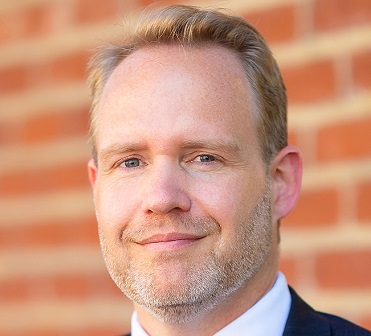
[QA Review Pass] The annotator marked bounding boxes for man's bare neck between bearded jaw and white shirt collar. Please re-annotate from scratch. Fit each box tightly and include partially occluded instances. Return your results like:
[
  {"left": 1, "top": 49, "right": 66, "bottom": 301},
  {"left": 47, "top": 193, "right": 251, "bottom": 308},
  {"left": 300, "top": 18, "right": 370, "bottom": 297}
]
[{"left": 134, "top": 258, "right": 278, "bottom": 336}]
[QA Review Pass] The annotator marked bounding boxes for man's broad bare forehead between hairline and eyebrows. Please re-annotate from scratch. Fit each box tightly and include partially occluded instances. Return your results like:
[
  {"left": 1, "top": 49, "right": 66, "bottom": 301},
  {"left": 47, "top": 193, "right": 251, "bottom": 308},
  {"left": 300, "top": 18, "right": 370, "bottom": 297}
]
[{"left": 96, "top": 45, "right": 260, "bottom": 154}]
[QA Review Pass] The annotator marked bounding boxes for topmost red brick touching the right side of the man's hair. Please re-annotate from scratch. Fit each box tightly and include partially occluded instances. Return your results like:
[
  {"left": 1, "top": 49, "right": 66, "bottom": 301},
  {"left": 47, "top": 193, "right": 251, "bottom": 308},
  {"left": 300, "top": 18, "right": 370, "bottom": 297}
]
[{"left": 243, "top": 5, "right": 296, "bottom": 43}]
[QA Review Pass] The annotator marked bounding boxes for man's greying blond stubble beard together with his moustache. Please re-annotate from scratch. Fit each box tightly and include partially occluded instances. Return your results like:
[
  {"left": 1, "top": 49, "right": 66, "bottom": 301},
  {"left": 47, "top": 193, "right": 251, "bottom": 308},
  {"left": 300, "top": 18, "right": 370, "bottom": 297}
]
[{"left": 100, "top": 183, "right": 272, "bottom": 324}]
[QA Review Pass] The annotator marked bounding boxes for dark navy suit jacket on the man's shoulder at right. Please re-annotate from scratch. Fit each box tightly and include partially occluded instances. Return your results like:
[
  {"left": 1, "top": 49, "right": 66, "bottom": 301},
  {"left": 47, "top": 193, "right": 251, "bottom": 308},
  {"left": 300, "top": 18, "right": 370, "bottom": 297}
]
[{"left": 126, "top": 287, "right": 371, "bottom": 336}]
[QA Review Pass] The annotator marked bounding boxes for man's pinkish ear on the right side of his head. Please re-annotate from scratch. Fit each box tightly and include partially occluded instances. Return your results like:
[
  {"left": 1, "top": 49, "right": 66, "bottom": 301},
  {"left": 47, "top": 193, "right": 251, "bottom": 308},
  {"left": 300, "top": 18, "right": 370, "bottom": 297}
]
[{"left": 270, "top": 146, "right": 303, "bottom": 222}]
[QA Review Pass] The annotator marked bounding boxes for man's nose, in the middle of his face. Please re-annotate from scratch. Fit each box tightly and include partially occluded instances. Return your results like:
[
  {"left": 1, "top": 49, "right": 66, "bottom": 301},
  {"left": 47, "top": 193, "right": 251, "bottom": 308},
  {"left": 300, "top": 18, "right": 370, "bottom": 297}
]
[{"left": 142, "top": 158, "right": 191, "bottom": 214}]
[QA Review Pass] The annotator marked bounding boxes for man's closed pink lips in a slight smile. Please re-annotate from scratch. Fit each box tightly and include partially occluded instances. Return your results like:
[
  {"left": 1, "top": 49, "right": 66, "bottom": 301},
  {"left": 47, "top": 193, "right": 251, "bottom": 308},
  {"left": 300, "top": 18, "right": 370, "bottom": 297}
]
[{"left": 138, "top": 232, "right": 204, "bottom": 251}]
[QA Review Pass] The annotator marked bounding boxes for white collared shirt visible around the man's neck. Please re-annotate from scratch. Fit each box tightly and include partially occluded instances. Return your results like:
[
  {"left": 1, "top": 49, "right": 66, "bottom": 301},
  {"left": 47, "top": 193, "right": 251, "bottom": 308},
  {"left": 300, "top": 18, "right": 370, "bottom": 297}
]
[{"left": 131, "top": 272, "right": 291, "bottom": 336}]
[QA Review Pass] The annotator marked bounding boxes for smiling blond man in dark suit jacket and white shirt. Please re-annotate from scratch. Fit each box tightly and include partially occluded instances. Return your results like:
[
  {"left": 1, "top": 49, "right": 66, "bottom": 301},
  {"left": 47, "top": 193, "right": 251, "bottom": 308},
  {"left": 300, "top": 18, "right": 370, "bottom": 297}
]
[{"left": 89, "top": 6, "right": 370, "bottom": 336}]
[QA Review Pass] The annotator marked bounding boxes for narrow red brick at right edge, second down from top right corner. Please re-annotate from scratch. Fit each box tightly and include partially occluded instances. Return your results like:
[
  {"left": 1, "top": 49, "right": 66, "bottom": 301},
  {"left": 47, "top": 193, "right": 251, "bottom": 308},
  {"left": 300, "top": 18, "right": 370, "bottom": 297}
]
[{"left": 353, "top": 49, "right": 371, "bottom": 89}]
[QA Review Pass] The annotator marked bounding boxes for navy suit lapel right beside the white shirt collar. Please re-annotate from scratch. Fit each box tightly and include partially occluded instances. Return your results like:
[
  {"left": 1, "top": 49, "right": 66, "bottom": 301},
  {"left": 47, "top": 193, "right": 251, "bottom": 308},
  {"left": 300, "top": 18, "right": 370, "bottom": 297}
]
[{"left": 283, "top": 287, "right": 331, "bottom": 336}]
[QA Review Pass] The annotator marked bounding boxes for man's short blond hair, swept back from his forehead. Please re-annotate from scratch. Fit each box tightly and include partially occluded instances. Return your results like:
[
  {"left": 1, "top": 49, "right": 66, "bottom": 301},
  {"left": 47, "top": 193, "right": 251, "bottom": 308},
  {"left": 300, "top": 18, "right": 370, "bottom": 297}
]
[{"left": 89, "top": 5, "right": 287, "bottom": 164}]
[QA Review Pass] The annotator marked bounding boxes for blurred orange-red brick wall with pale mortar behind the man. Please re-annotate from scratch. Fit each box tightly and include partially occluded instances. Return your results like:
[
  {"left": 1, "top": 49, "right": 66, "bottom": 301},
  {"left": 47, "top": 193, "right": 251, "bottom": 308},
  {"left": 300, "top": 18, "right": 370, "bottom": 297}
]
[{"left": 0, "top": 0, "right": 371, "bottom": 335}]
